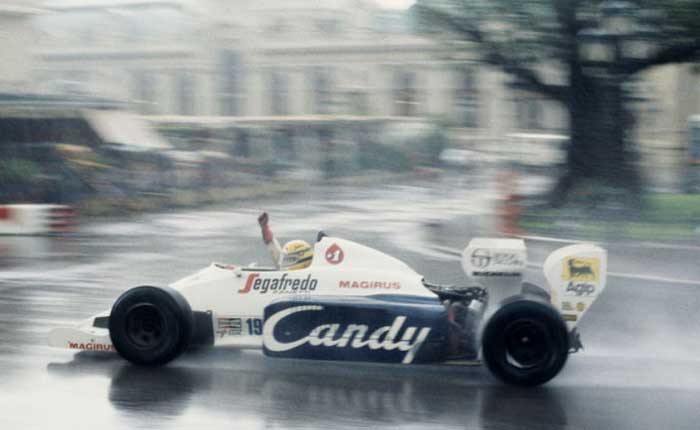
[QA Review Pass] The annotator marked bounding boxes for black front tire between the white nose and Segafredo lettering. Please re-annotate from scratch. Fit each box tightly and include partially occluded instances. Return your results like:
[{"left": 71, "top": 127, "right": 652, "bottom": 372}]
[{"left": 109, "top": 286, "right": 194, "bottom": 366}]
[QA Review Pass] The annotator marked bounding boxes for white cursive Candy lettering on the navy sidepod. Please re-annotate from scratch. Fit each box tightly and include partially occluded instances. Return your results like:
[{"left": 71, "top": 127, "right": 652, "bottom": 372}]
[{"left": 263, "top": 305, "right": 431, "bottom": 363}]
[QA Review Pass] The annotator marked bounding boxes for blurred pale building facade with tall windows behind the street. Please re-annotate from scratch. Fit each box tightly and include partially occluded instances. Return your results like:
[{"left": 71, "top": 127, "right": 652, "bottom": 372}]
[{"left": 32, "top": 0, "right": 700, "bottom": 155}]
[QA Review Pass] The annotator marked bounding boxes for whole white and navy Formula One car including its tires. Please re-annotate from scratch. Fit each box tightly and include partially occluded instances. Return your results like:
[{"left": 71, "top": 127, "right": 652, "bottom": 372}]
[{"left": 49, "top": 233, "right": 607, "bottom": 386}]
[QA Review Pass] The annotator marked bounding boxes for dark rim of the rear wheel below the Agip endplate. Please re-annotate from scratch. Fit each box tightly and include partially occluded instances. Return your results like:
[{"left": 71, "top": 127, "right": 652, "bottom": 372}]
[{"left": 505, "top": 320, "right": 552, "bottom": 369}]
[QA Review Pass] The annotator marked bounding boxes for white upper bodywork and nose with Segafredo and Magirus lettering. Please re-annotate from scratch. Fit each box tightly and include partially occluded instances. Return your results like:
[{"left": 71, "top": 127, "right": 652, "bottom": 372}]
[{"left": 49, "top": 237, "right": 437, "bottom": 351}]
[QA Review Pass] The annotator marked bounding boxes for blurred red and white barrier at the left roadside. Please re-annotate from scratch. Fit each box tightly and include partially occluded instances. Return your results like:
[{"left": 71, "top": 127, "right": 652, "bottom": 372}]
[{"left": 0, "top": 204, "right": 77, "bottom": 235}]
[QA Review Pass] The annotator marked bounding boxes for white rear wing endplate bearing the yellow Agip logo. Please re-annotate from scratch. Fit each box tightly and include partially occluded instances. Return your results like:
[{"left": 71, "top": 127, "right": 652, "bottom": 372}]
[{"left": 544, "top": 244, "right": 608, "bottom": 330}]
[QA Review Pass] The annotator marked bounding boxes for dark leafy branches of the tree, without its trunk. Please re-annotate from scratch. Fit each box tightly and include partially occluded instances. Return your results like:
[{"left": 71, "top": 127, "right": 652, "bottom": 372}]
[{"left": 413, "top": 0, "right": 700, "bottom": 88}]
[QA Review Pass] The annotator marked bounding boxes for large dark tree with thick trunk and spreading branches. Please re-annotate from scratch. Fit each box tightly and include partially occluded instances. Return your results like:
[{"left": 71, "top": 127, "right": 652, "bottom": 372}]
[{"left": 412, "top": 0, "right": 700, "bottom": 204}]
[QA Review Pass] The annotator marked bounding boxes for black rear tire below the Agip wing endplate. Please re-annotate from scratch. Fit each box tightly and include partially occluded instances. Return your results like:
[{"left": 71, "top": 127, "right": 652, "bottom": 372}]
[{"left": 481, "top": 296, "right": 569, "bottom": 386}]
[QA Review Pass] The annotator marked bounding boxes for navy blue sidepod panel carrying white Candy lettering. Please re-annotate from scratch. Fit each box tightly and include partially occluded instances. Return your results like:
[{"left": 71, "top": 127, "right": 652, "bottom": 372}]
[{"left": 263, "top": 295, "right": 448, "bottom": 363}]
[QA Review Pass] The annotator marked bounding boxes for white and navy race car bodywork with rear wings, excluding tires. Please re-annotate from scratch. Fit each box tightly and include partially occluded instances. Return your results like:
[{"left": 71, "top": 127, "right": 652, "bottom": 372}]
[{"left": 49, "top": 235, "right": 606, "bottom": 384}]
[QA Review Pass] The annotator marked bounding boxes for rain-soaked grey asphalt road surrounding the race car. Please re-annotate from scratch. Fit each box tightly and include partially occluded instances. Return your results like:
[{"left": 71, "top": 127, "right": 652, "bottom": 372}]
[{"left": 0, "top": 176, "right": 700, "bottom": 429}]
